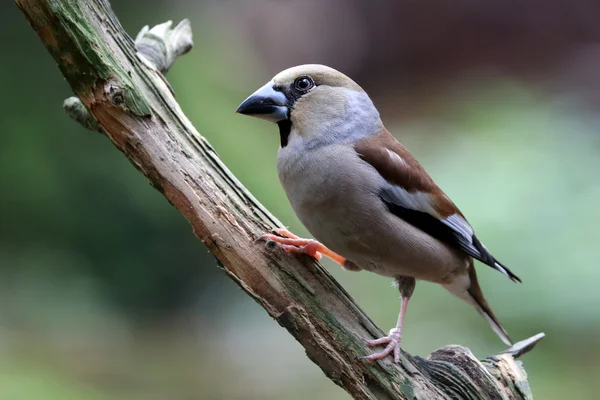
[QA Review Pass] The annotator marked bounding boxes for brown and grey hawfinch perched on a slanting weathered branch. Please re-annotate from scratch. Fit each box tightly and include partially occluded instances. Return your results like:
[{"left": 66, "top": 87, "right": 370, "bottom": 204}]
[{"left": 236, "top": 64, "right": 521, "bottom": 363}]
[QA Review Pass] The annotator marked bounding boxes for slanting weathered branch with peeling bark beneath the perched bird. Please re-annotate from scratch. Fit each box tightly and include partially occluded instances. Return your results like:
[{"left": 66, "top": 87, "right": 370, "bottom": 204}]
[{"left": 16, "top": 0, "right": 543, "bottom": 399}]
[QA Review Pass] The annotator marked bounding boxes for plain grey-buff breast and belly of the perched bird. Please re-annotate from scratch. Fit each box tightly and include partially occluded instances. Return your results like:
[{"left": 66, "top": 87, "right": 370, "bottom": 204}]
[{"left": 278, "top": 146, "right": 469, "bottom": 283}]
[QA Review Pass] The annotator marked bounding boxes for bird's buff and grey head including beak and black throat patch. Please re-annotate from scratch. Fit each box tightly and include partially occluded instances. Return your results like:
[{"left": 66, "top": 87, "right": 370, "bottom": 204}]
[{"left": 237, "top": 64, "right": 381, "bottom": 147}]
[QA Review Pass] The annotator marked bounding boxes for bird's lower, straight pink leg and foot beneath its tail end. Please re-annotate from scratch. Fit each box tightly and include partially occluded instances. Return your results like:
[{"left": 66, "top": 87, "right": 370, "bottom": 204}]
[{"left": 361, "top": 276, "right": 416, "bottom": 363}]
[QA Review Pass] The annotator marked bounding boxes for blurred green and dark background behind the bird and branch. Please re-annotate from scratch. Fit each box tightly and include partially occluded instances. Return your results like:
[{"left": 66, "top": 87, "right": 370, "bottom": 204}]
[{"left": 0, "top": 0, "right": 600, "bottom": 400}]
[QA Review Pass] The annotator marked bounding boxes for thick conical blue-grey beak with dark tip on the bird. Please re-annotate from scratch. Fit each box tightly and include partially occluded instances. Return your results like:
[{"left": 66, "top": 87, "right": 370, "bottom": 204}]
[{"left": 236, "top": 82, "right": 289, "bottom": 122}]
